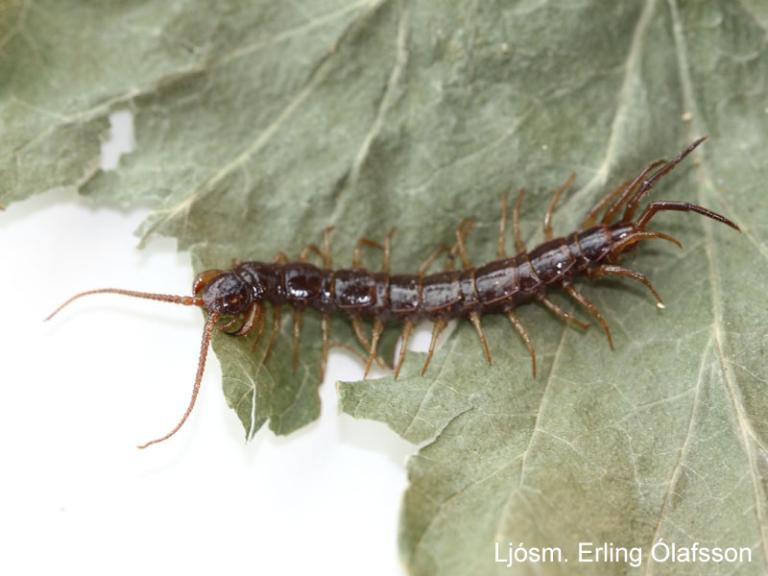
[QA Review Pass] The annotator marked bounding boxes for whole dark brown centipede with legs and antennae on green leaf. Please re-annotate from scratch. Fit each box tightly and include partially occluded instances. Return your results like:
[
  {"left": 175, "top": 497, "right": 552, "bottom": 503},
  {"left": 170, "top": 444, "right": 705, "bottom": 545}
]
[{"left": 46, "top": 137, "right": 740, "bottom": 449}]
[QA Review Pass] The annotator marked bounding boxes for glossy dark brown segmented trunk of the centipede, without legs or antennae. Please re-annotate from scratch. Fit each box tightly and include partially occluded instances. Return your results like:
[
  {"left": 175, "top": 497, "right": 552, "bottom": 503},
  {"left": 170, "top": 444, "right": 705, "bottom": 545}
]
[{"left": 214, "top": 223, "right": 633, "bottom": 320}]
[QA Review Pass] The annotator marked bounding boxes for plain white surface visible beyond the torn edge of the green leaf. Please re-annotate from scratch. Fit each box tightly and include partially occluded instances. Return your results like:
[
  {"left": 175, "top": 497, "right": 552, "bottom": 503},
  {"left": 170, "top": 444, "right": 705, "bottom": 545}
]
[{"left": 0, "top": 112, "right": 414, "bottom": 576}]
